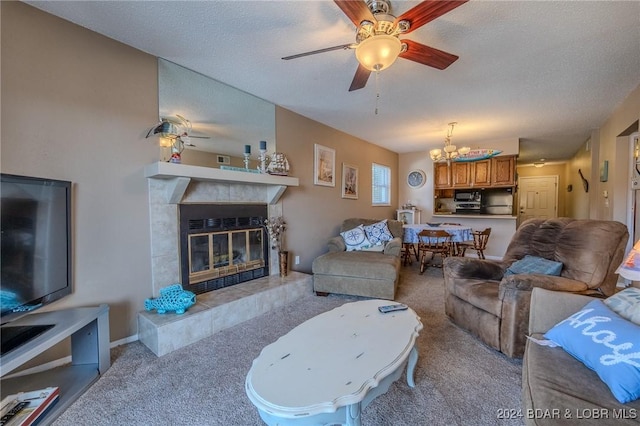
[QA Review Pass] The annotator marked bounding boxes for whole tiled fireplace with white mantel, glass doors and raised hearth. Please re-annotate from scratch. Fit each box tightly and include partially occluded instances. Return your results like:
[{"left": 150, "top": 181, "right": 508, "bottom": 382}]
[{"left": 138, "top": 162, "right": 312, "bottom": 356}]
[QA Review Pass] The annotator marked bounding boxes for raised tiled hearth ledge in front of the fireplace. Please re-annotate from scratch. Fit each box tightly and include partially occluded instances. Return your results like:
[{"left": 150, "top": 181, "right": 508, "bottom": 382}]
[{"left": 138, "top": 272, "right": 312, "bottom": 356}]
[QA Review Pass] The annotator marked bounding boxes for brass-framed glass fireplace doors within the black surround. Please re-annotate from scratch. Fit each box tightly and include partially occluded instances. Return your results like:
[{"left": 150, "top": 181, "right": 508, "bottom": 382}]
[{"left": 188, "top": 228, "right": 265, "bottom": 284}]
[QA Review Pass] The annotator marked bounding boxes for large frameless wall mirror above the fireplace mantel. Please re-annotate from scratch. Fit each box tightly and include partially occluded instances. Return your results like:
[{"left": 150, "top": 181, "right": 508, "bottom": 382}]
[{"left": 158, "top": 58, "right": 276, "bottom": 167}]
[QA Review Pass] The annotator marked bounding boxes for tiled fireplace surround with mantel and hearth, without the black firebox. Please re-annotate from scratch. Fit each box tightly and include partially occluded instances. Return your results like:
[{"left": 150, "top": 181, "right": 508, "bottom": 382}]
[{"left": 138, "top": 162, "right": 312, "bottom": 356}]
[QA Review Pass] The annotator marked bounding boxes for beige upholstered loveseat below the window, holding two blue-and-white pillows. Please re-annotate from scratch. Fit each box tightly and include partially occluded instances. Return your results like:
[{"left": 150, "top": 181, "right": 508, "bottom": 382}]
[{"left": 311, "top": 218, "right": 403, "bottom": 300}]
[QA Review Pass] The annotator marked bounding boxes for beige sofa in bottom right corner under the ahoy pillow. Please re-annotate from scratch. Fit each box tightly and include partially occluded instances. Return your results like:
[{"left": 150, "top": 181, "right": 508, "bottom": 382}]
[{"left": 522, "top": 288, "right": 640, "bottom": 425}]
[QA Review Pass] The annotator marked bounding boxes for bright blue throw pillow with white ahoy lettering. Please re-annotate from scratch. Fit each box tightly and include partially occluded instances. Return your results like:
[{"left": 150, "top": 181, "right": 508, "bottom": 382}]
[{"left": 544, "top": 299, "right": 640, "bottom": 404}]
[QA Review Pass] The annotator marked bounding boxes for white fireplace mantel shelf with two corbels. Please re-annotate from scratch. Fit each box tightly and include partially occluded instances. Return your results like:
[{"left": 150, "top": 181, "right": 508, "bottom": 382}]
[{"left": 144, "top": 161, "right": 299, "bottom": 204}]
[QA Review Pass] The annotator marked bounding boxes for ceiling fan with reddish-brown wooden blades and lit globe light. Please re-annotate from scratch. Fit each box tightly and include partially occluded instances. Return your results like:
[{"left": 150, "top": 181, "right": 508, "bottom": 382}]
[{"left": 282, "top": 0, "right": 468, "bottom": 92}]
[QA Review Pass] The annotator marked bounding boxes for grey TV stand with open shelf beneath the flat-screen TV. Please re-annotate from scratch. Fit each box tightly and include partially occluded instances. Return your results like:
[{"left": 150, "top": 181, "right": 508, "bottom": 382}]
[{"left": 0, "top": 305, "right": 111, "bottom": 424}]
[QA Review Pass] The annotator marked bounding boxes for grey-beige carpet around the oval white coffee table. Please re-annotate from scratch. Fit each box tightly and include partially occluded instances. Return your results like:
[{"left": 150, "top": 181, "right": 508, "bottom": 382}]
[{"left": 54, "top": 262, "right": 522, "bottom": 426}]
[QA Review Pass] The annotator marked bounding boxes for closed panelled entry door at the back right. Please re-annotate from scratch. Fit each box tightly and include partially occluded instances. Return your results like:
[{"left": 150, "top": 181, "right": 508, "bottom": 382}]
[{"left": 518, "top": 176, "right": 558, "bottom": 225}]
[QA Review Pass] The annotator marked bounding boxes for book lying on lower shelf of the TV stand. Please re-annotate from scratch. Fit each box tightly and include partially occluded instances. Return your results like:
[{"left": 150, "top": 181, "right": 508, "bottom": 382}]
[{"left": 0, "top": 386, "right": 60, "bottom": 426}]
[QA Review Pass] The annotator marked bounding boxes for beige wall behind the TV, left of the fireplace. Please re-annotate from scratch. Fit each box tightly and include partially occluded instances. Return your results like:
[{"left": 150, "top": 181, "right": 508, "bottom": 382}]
[{"left": 0, "top": 2, "right": 158, "bottom": 352}]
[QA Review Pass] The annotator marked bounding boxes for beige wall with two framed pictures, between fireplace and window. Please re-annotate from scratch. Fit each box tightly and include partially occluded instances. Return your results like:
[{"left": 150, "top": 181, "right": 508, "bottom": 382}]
[{"left": 276, "top": 107, "right": 398, "bottom": 272}]
